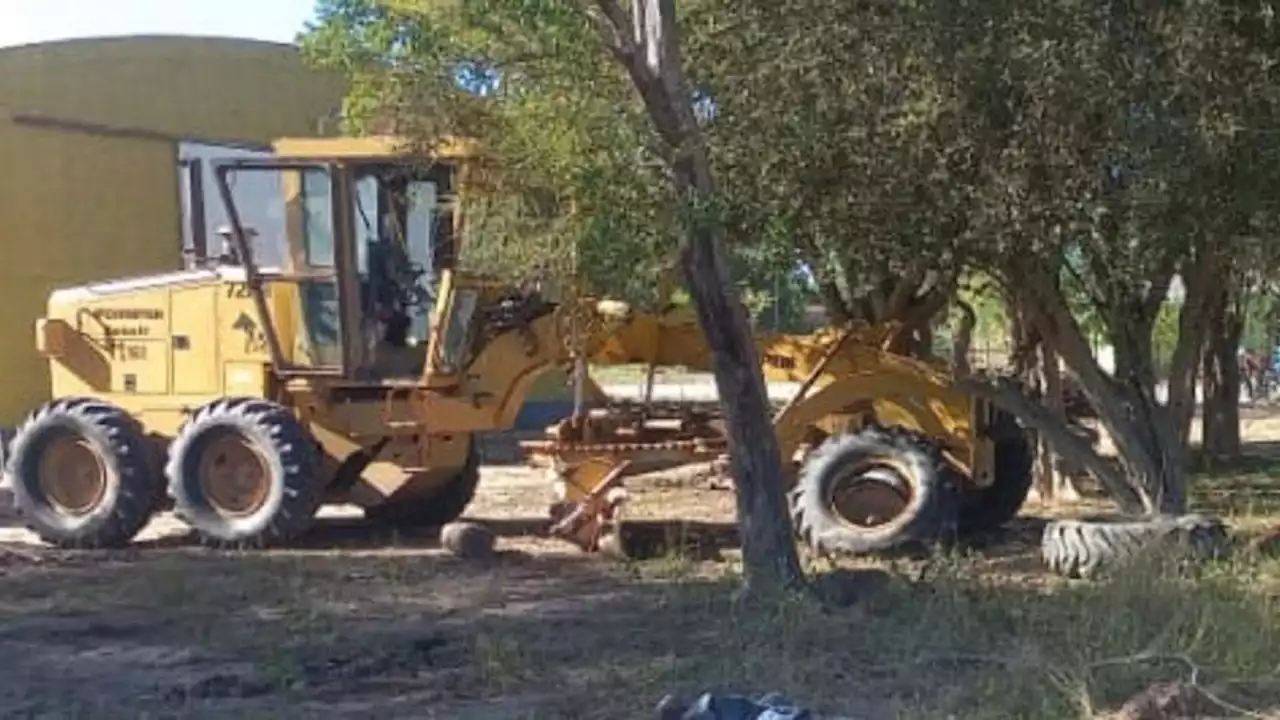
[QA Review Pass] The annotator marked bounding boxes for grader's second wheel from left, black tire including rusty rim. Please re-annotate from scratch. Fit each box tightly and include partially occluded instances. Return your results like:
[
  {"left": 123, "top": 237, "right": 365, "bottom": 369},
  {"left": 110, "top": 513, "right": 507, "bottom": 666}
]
[{"left": 165, "top": 397, "right": 324, "bottom": 548}]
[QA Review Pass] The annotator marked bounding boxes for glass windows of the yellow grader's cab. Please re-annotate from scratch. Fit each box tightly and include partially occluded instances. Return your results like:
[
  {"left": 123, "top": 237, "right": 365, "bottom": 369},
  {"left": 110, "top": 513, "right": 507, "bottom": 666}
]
[{"left": 216, "top": 163, "right": 453, "bottom": 379}]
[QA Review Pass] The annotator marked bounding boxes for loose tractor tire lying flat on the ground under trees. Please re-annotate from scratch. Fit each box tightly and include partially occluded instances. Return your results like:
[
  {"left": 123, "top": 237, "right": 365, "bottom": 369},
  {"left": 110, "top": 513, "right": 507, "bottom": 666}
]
[{"left": 1041, "top": 514, "right": 1230, "bottom": 578}]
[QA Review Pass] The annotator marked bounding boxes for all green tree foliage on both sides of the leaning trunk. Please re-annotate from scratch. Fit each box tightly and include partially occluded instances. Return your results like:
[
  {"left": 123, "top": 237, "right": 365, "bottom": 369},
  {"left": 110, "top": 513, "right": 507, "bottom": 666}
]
[{"left": 305, "top": 0, "right": 1280, "bottom": 507}]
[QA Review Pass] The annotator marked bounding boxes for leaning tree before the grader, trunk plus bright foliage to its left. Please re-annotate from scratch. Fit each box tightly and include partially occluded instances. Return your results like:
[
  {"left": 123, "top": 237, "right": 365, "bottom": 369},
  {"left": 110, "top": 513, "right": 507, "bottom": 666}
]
[{"left": 307, "top": 0, "right": 804, "bottom": 592}]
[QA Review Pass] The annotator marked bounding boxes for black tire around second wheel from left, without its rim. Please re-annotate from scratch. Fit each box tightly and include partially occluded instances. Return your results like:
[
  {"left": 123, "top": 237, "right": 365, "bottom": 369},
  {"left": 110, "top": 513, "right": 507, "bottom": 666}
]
[{"left": 165, "top": 397, "right": 324, "bottom": 548}]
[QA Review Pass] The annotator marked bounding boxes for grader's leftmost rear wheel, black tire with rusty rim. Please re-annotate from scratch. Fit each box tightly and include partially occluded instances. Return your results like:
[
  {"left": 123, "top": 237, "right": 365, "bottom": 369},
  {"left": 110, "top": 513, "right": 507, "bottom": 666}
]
[{"left": 8, "top": 397, "right": 164, "bottom": 548}]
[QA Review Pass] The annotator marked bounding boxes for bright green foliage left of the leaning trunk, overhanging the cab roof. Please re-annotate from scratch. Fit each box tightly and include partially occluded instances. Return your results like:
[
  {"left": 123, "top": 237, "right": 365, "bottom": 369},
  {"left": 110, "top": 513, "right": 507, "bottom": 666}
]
[{"left": 302, "top": 0, "right": 675, "bottom": 305}]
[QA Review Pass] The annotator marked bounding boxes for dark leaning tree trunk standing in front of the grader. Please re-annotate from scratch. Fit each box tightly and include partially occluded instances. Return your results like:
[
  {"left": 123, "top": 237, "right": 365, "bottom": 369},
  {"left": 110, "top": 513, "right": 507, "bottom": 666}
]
[{"left": 596, "top": 0, "right": 804, "bottom": 593}]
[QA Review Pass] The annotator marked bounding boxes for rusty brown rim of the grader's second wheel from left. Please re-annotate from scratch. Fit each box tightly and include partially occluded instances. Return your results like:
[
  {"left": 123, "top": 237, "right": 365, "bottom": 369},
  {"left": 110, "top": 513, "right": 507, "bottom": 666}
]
[{"left": 196, "top": 430, "right": 271, "bottom": 516}]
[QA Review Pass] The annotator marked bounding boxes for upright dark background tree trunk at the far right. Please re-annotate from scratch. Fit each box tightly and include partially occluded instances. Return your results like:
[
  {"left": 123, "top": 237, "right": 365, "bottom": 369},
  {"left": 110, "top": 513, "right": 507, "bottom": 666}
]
[{"left": 1201, "top": 290, "right": 1244, "bottom": 466}]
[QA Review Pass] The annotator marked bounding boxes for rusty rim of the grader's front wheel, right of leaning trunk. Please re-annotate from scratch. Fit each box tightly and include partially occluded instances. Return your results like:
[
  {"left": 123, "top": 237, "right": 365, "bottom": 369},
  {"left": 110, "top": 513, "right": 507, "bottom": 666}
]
[{"left": 828, "top": 457, "right": 911, "bottom": 529}]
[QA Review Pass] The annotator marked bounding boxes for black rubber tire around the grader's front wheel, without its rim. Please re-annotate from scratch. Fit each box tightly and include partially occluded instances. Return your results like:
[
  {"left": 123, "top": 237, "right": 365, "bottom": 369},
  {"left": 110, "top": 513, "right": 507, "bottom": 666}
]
[{"left": 788, "top": 425, "right": 959, "bottom": 555}]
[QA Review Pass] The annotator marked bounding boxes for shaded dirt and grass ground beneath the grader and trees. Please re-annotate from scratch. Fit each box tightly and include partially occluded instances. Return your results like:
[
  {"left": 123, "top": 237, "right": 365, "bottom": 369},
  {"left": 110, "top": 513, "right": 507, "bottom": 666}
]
[{"left": 0, "top": 411, "right": 1280, "bottom": 720}]
